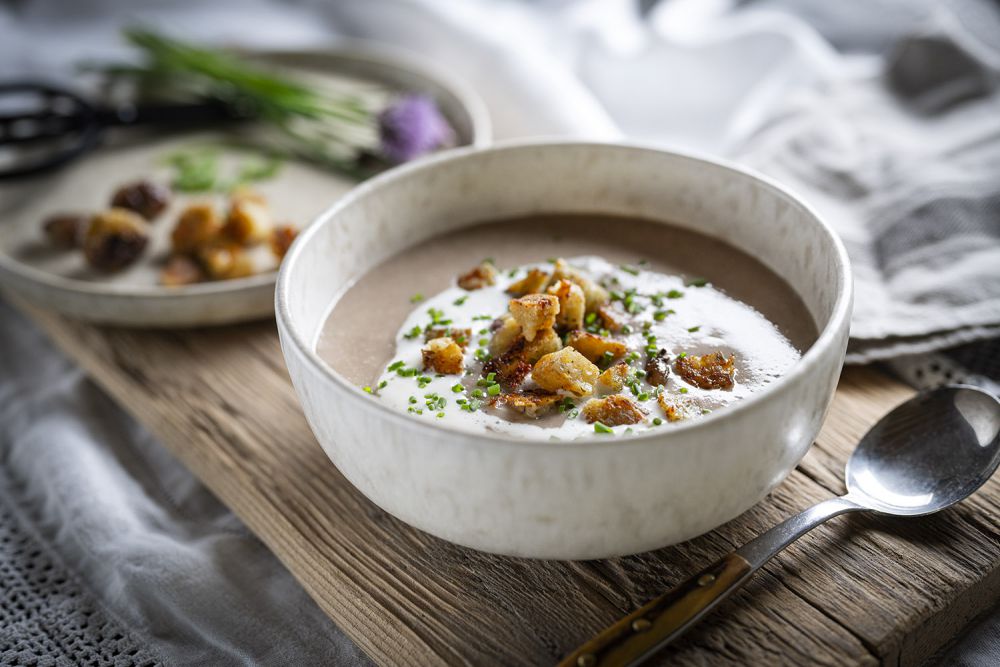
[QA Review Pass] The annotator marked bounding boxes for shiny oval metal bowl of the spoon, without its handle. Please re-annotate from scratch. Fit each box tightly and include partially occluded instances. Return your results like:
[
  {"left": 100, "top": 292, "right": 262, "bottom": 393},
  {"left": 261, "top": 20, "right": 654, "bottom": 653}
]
[{"left": 846, "top": 385, "right": 1000, "bottom": 516}]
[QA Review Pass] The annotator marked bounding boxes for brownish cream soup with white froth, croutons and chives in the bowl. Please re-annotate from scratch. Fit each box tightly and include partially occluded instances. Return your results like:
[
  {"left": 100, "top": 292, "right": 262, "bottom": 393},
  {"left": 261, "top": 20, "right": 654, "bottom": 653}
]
[{"left": 317, "top": 214, "right": 817, "bottom": 440}]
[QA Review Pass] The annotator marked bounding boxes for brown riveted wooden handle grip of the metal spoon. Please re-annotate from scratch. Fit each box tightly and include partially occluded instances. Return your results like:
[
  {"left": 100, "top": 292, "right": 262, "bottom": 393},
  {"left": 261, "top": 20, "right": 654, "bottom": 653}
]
[{"left": 559, "top": 553, "right": 755, "bottom": 667}]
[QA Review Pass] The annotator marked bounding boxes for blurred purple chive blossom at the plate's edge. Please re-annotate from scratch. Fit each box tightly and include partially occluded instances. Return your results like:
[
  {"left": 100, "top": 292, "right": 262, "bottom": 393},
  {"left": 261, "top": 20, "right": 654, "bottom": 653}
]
[{"left": 378, "top": 95, "right": 453, "bottom": 163}]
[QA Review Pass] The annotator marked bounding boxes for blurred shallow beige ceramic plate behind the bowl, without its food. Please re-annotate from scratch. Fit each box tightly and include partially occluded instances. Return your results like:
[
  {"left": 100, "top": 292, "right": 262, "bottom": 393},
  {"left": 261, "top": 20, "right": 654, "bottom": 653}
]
[{"left": 0, "top": 44, "right": 490, "bottom": 327}]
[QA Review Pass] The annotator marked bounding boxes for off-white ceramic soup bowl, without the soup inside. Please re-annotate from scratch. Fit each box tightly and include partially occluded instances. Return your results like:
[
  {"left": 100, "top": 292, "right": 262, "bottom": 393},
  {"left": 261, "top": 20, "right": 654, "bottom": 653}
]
[{"left": 276, "top": 142, "right": 852, "bottom": 559}]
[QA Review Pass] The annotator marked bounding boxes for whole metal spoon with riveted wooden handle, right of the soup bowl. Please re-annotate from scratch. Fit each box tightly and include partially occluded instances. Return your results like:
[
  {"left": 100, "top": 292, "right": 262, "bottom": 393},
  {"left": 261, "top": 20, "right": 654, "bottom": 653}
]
[{"left": 560, "top": 385, "right": 1000, "bottom": 667}]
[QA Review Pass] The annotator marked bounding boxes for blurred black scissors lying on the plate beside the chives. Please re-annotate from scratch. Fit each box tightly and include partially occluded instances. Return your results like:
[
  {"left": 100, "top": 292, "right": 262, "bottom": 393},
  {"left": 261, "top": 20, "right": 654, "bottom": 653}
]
[{"left": 0, "top": 81, "right": 253, "bottom": 181}]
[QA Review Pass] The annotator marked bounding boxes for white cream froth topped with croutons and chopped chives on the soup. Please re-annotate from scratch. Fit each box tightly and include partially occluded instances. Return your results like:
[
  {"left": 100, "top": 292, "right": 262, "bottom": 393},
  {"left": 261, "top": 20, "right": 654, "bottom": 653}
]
[{"left": 365, "top": 256, "right": 800, "bottom": 440}]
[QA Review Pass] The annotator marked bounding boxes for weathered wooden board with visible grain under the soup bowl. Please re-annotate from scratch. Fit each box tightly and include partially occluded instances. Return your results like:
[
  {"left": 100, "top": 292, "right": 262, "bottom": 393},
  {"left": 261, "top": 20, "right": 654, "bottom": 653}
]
[{"left": 9, "top": 308, "right": 1000, "bottom": 667}]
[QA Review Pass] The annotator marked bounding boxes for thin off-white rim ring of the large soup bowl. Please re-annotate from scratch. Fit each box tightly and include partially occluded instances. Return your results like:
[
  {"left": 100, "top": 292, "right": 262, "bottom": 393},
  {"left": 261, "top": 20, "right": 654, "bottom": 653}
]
[{"left": 274, "top": 138, "right": 854, "bottom": 450}]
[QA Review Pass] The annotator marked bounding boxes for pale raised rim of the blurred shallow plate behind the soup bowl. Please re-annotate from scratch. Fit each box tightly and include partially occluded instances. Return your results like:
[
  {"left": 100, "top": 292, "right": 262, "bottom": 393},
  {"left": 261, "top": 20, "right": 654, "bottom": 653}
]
[{"left": 0, "top": 38, "right": 493, "bottom": 304}]
